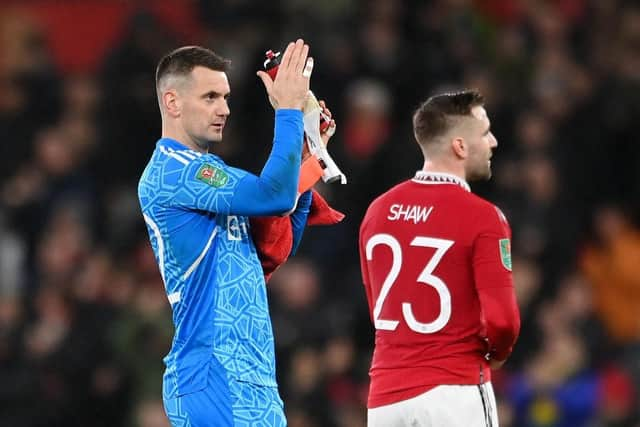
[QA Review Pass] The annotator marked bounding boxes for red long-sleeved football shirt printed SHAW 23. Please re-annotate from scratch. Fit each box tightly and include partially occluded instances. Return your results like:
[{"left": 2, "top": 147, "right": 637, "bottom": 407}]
[{"left": 359, "top": 171, "right": 520, "bottom": 408}]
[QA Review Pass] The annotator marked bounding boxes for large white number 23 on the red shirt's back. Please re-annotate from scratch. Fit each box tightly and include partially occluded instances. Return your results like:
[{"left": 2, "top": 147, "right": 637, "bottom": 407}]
[{"left": 366, "top": 234, "right": 454, "bottom": 334}]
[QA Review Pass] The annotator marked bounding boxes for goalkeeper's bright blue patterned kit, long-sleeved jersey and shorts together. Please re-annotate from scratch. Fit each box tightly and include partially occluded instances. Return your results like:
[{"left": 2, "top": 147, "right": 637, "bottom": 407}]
[{"left": 138, "top": 110, "right": 311, "bottom": 427}]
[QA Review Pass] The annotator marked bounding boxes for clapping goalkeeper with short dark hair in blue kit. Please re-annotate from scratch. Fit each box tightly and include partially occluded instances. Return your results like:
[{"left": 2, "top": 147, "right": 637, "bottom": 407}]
[{"left": 138, "top": 40, "right": 322, "bottom": 427}]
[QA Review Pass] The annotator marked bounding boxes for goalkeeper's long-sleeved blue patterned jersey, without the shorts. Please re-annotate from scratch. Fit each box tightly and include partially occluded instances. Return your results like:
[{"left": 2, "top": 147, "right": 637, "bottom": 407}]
[{"left": 138, "top": 111, "right": 303, "bottom": 396}]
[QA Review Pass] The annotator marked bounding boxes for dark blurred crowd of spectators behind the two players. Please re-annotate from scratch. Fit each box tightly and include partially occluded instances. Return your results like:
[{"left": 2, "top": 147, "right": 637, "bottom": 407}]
[{"left": 0, "top": 0, "right": 640, "bottom": 427}]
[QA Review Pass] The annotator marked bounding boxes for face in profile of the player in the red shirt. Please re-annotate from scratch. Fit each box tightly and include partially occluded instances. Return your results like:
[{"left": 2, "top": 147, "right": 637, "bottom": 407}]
[{"left": 465, "top": 106, "right": 498, "bottom": 181}]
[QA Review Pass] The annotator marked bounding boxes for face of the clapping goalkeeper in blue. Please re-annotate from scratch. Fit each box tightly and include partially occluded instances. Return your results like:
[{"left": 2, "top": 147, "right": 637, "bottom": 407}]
[{"left": 180, "top": 67, "right": 231, "bottom": 150}]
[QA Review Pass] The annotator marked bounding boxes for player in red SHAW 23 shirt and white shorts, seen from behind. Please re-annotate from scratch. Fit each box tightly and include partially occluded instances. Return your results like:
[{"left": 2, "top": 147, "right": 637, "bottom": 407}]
[{"left": 359, "top": 91, "right": 520, "bottom": 427}]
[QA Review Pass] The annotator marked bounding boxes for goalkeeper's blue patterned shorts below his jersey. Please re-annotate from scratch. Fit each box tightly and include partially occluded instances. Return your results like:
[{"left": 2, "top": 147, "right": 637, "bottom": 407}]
[{"left": 163, "top": 363, "right": 287, "bottom": 427}]
